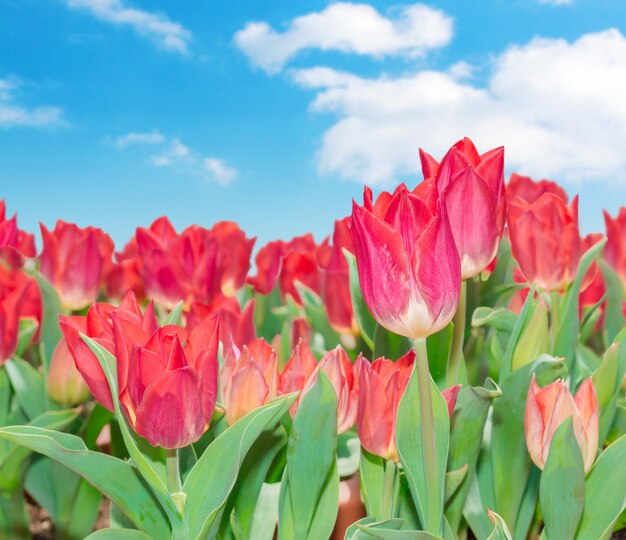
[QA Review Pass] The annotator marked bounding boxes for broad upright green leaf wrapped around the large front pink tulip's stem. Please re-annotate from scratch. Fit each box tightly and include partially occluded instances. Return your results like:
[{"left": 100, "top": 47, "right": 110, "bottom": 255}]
[{"left": 396, "top": 358, "right": 450, "bottom": 534}]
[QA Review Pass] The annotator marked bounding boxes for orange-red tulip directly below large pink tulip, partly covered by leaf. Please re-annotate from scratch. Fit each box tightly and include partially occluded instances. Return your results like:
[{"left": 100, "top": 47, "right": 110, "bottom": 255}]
[{"left": 355, "top": 350, "right": 461, "bottom": 462}]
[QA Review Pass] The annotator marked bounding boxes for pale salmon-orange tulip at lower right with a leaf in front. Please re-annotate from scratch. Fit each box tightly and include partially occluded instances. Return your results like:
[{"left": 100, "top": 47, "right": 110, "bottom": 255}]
[{"left": 524, "top": 376, "right": 599, "bottom": 472}]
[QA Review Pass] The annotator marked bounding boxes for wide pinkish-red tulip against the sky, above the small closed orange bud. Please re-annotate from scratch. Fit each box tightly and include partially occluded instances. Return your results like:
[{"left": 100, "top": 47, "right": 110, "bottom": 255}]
[{"left": 41, "top": 220, "right": 113, "bottom": 310}]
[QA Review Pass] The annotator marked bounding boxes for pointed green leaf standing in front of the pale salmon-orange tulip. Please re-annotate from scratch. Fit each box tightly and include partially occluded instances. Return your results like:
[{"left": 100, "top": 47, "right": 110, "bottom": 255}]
[{"left": 539, "top": 418, "right": 585, "bottom": 540}]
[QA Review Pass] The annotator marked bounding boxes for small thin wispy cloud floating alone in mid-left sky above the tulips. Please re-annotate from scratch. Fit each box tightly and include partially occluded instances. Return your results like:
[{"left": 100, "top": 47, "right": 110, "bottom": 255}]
[{"left": 109, "top": 130, "right": 239, "bottom": 185}]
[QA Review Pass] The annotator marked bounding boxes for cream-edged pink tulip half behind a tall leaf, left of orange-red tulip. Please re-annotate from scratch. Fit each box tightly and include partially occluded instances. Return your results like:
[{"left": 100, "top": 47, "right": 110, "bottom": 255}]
[{"left": 316, "top": 345, "right": 359, "bottom": 434}]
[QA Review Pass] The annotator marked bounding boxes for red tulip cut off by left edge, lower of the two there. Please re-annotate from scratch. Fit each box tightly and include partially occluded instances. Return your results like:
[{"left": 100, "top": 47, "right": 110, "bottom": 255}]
[{"left": 0, "top": 264, "right": 43, "bottom": 365}]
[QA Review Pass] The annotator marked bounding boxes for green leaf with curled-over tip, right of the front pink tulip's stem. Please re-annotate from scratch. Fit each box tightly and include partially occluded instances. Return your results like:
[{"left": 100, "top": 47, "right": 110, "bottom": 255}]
[{"left": 446, "top": 379, "right": 502, "bottom": 532}]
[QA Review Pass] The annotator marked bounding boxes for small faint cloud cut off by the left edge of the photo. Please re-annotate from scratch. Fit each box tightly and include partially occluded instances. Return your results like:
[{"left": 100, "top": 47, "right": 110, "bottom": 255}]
[{"left": 0, "top": 79, "right": 64, "bottom": 127}]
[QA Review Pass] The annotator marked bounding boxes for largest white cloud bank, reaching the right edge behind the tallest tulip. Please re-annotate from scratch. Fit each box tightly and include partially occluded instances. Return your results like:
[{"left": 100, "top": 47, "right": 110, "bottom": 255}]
[{"left": 293, "top": 30, "right": 626, "bottom": 184}]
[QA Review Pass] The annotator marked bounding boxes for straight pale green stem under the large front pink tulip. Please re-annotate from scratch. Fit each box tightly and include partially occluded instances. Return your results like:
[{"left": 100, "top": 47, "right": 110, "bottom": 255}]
[{"left": 414, "top": 339, "right": 442, "bottom": 535}]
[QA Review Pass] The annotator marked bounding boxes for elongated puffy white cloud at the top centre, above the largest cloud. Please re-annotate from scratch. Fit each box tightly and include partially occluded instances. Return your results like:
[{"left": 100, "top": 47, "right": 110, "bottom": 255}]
[{"left": 235, "top": 2, "right": 453, "bottom": 73}]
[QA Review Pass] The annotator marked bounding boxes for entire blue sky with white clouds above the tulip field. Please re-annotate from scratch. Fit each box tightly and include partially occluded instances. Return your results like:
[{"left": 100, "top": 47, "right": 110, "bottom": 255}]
[{"left": 0, "top": 0, "right": 626, "bottom": 248}]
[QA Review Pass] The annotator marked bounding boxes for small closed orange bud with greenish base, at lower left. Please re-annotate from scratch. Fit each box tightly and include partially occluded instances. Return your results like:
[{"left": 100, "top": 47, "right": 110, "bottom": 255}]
[{"left": 48, "top": 338, "right": 89, "bottom": 406}]
